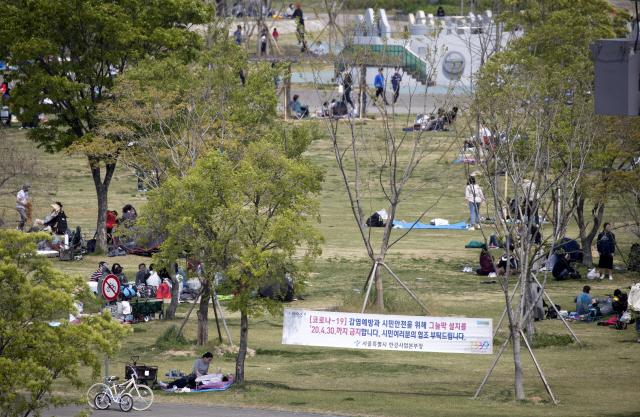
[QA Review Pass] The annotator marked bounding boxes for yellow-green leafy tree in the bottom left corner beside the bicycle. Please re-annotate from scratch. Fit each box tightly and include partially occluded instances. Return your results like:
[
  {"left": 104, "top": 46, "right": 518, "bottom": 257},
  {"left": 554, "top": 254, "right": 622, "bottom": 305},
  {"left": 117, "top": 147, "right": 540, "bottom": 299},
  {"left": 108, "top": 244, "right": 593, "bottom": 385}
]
[{"left": 0, "top": 230, "right": 131, "bottom": 416}]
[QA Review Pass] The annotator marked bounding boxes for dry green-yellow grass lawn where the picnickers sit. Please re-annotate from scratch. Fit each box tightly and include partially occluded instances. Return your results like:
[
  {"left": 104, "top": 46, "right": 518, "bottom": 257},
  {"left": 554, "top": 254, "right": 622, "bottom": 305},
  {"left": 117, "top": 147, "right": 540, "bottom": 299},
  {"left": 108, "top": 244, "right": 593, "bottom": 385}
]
[{"left": 1, "top": 112, "right": 640, "bottom": 416}]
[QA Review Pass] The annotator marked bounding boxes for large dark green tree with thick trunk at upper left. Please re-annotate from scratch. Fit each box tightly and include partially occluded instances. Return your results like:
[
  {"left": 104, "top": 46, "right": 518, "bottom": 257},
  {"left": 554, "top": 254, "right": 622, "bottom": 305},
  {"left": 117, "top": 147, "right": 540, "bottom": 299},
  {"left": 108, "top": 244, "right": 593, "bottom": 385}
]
[{"left": 0, "top": 0, "right": 214, "bottom": 249}]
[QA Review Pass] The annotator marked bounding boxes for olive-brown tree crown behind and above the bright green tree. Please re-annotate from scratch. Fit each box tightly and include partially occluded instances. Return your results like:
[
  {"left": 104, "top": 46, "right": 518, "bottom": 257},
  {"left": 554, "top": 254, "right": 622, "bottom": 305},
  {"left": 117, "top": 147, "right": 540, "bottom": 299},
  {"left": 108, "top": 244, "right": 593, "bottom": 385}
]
[{"left": 99, "top": 39, "right": 280, "bottom": 318}]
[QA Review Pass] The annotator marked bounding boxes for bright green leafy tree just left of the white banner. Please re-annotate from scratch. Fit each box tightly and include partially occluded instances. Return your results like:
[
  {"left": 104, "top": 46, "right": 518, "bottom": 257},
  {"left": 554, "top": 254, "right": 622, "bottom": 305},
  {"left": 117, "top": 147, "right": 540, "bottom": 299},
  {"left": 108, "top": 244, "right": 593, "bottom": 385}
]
[{"left": 143, "top": 132, "right": 324, "bottom": 382}]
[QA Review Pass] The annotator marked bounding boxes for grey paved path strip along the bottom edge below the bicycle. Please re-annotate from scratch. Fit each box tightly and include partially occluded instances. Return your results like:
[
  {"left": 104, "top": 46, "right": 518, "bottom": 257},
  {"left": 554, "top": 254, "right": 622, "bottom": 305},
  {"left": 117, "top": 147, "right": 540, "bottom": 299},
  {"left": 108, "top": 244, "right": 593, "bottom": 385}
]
[{"left": 42, "top": 402, "right": 342, "bottom": 417}]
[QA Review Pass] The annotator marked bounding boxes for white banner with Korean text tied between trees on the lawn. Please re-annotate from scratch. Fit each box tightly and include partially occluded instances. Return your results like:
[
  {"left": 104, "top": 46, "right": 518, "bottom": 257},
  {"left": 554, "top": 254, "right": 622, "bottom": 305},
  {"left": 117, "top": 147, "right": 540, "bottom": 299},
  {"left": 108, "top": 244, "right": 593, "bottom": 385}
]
[{"left": 282, "top": 309, "right": 493, "bottom": 354}]
